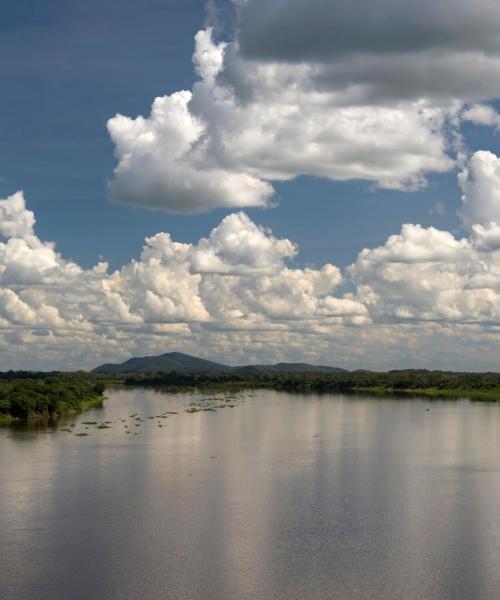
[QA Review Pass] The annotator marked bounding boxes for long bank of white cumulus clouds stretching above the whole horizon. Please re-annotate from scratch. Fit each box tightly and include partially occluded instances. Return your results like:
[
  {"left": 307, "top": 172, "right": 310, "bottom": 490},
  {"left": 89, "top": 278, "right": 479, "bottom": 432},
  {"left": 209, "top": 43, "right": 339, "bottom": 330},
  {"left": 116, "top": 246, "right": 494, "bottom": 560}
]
[{"left": 4, "top": 157, "right": 500, "bottom": 369}]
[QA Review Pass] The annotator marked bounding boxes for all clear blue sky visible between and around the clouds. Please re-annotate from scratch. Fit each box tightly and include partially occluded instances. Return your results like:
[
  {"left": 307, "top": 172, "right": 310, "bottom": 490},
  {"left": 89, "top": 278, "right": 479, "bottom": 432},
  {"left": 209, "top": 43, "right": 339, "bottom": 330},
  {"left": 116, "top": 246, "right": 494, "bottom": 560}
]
[{"left": 0, "top": 0, "right": 480, "bottom": 267}]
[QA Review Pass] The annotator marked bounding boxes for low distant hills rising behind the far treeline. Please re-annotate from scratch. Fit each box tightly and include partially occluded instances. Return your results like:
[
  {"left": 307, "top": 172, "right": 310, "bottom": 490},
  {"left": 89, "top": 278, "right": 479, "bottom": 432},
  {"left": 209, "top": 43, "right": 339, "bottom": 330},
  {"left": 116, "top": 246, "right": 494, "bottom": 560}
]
[{"left": 94, "top": 352, "right": 345, "bottom": 374}]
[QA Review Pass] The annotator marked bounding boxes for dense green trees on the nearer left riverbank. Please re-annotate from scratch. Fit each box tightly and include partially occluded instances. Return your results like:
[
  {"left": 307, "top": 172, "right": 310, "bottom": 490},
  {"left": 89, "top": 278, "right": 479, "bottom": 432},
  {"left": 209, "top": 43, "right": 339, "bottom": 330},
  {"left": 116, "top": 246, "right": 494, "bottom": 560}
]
[{"left": 0, "top": 371, "right": 105, "bottom": 425}]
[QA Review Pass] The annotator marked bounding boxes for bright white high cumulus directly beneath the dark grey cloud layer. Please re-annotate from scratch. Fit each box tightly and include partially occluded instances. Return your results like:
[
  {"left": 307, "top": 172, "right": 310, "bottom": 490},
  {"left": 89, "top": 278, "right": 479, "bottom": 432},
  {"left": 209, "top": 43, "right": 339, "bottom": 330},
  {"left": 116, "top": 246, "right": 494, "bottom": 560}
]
[{"left": 108, "top": 20, "right": 468, "bottom": 213}]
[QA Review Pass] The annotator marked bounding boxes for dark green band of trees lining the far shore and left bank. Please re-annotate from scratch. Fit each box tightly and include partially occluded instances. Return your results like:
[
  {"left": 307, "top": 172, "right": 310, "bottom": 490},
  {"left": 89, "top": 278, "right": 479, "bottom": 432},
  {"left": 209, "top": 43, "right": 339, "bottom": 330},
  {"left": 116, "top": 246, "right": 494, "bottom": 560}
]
[{"left": 0, "top": 369, "right": 500, "bottom": 422}]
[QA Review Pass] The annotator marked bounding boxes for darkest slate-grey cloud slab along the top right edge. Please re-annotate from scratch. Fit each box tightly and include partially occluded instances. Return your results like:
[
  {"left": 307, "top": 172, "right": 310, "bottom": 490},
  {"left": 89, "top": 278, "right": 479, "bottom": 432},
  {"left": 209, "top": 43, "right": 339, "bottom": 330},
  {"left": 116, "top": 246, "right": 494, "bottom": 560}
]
[{"left": 236, "top": 0, "right": 500, "bottom": 62}]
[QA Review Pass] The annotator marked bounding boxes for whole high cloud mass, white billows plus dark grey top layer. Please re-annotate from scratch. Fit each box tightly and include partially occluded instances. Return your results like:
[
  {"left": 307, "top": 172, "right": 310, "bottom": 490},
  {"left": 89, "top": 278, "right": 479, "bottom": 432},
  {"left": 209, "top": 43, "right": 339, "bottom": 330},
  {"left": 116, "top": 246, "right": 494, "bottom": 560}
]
[{"left": 104, "top": 0, "right": 500, "bottom": 212}]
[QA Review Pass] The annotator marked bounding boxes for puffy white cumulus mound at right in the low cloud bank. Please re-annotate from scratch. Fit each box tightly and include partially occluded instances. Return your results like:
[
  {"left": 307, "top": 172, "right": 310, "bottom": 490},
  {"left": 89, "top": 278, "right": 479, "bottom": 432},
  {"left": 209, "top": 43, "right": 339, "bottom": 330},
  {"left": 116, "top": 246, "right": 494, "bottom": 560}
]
[{"left": 349, "top": 218, "right": 500, "bottom": 327}]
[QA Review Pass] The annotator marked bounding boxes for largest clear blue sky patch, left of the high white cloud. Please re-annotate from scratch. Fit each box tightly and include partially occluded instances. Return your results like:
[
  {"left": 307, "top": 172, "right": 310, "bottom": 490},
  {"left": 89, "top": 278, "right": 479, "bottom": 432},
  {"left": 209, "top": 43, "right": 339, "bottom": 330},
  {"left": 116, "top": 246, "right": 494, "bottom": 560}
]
[{"left": 0, "top": 0, "right": 205, "bottom": 266}]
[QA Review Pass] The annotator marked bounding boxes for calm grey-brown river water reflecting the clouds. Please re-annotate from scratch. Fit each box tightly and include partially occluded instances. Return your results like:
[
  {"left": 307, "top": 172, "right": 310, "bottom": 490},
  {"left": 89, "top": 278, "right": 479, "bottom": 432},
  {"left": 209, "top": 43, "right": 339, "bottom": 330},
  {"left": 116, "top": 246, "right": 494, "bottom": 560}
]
[{"left": 0, "top": 390, "right": 500, "bottom": 600}]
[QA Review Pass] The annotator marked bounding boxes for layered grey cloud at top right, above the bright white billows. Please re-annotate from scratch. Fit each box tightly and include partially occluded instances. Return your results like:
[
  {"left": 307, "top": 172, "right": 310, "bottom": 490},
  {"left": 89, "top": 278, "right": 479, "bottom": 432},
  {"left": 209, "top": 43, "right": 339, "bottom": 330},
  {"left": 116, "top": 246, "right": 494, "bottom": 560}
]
[{"left": 237, "top": 0, "right": 500, "bottom": 99}]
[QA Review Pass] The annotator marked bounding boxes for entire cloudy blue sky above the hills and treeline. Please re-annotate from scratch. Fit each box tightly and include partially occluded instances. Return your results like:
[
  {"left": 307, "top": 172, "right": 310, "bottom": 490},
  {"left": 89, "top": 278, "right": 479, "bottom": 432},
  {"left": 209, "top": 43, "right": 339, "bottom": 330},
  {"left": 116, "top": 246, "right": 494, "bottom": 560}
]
[{"left": 0, "top": 0, "right": 500, "bottom": 370}]
